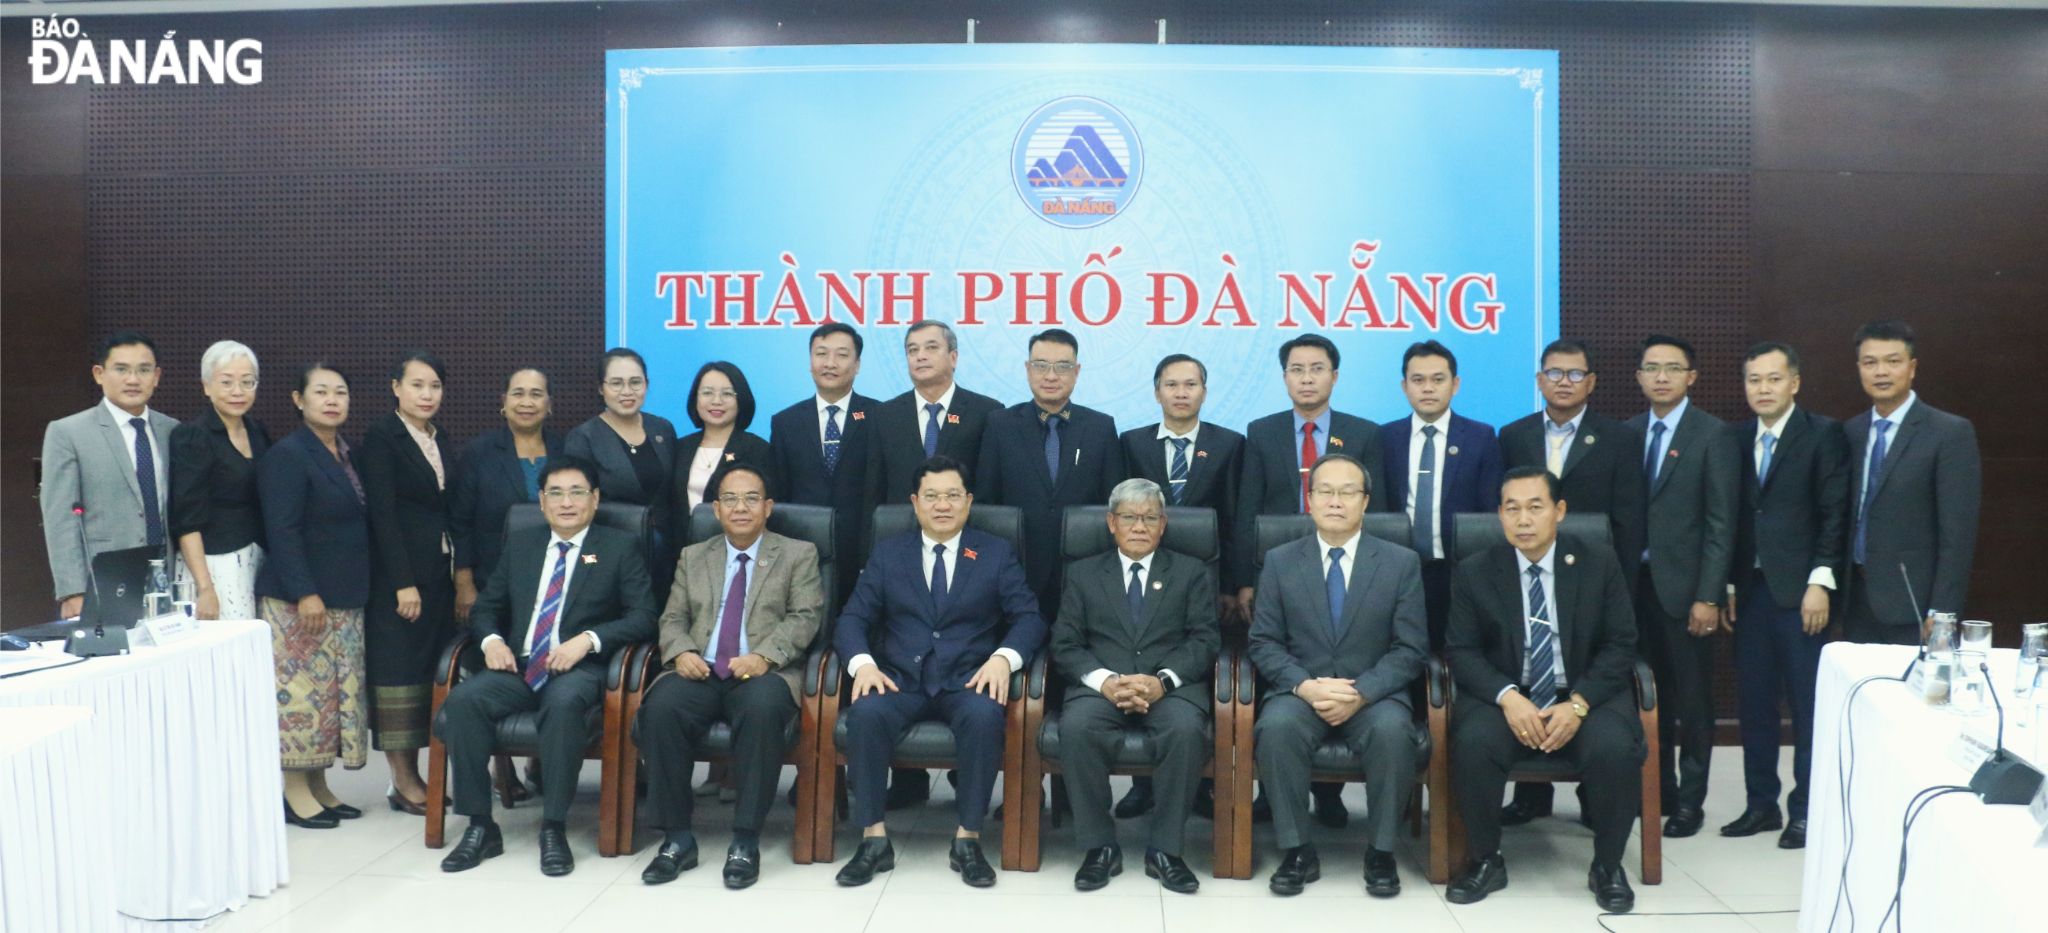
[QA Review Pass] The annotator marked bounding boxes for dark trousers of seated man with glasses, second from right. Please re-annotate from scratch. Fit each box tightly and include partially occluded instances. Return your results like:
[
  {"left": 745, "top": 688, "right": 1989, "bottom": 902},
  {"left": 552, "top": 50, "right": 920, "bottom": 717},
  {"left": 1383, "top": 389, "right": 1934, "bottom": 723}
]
[{"left": 1251, "top": 694, "right": 1417, "bottom": 851}]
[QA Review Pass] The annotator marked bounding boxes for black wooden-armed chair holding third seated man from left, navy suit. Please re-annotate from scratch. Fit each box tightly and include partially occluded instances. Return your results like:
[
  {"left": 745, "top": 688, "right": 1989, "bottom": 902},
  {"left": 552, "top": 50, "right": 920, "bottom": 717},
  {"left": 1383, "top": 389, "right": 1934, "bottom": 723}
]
[{"left": 811, "top": 505, "right": 1044, "bottom": 872}]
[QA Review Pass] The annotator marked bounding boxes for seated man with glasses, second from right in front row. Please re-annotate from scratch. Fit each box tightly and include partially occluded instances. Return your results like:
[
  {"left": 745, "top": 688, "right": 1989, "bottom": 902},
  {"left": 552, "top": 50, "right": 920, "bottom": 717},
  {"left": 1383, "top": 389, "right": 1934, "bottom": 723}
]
[{"left": 1249, "top": 454, "right": 1430, "bottom": 898}]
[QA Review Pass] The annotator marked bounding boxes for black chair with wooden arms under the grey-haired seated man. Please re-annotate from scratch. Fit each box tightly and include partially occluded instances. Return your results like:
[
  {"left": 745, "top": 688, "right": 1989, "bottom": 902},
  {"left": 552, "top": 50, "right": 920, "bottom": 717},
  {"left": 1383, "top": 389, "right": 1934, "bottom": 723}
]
[{"left": 1022, "top": 505, "right": 1237, "bottom": 878}]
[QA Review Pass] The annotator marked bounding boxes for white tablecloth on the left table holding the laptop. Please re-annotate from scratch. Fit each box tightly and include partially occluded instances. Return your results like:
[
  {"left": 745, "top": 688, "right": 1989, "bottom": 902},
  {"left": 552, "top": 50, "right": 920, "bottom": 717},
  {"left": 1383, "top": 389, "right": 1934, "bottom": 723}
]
[{"left": 0, "top": 622, "right": 289, "bottom": 929}]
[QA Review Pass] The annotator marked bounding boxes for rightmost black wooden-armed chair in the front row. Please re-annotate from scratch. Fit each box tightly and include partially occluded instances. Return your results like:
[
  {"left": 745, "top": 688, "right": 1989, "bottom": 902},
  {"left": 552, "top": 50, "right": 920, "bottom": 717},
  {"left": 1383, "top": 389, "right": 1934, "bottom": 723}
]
[{"left": 1444, "top": 512, "right": 1663, "bottom": 884}]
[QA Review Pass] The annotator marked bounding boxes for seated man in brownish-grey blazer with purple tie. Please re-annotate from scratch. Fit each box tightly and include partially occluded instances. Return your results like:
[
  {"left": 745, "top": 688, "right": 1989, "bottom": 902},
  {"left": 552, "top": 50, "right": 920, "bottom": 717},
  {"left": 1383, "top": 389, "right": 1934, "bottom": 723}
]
[{"left": 635, "top": 462, "right": 825, "bottom": 890}]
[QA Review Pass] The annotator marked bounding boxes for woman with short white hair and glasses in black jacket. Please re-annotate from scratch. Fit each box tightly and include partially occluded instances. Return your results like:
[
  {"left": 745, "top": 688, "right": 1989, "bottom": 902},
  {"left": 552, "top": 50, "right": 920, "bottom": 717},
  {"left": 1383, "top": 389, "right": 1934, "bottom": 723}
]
[{"left": 170, "top": 340, "right": 270, "bottom": 620}]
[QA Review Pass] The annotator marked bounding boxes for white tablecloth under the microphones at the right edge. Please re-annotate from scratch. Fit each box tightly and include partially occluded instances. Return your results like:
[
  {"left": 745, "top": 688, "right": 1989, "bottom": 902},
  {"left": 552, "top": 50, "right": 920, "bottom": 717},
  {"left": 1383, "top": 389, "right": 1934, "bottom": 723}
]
[{"left": 1798, "top": 642, "right": 2048, "bottom": 933}]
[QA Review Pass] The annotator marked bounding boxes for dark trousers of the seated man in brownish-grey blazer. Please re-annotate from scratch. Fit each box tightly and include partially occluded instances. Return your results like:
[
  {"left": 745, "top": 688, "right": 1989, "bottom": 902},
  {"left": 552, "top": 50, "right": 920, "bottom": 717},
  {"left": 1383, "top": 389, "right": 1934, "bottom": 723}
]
[{"left": 633, "top": 673, "right": 797, "bottom": 833}]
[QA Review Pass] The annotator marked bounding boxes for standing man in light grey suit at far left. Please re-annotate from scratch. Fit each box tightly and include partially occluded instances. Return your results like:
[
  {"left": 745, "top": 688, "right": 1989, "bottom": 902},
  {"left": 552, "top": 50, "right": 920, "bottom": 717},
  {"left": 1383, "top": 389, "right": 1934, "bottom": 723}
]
[{"left": 37, "top": 331, "right": 178, "bottom": 618}]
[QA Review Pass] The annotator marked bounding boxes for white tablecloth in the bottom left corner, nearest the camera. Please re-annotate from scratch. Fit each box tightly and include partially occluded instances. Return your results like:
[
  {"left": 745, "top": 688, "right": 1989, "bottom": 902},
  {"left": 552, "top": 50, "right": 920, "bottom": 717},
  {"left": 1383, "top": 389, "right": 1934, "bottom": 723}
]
[{"left": 0, "top": 706, "right": 115, "bottom": 933}]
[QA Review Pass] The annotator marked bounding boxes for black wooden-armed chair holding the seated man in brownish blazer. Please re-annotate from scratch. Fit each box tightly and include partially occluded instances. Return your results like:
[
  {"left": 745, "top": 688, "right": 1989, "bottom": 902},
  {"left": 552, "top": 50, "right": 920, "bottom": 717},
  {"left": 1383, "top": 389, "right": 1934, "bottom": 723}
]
[{"left": 618, "top": 503, "right": 840, "bottom": 865}]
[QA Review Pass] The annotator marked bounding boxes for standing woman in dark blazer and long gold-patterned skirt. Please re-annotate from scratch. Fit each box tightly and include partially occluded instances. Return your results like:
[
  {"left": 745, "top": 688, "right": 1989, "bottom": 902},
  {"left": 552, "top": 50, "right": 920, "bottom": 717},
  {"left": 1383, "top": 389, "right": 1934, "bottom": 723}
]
[{"left": 256, "top": 362, "right": 371, "bottom": 829}]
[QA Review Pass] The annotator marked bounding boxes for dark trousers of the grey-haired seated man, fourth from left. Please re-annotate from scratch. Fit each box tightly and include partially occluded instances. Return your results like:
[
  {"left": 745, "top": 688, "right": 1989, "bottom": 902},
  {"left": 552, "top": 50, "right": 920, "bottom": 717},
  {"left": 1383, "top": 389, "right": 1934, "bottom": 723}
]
[{"left": 1059, "top": 694, "right": 1212, "bottom": 855}]
